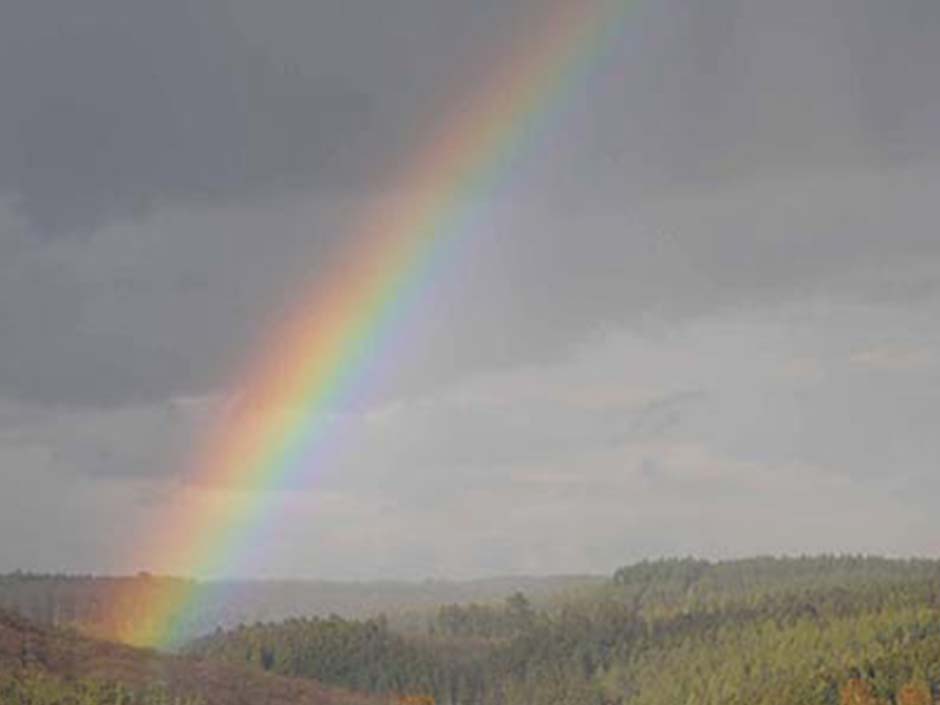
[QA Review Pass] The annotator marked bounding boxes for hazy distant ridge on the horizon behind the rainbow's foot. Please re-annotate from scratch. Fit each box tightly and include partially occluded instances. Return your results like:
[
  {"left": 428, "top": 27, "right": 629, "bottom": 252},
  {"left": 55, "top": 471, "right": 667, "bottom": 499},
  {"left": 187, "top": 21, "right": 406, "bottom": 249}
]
[{"left": 0, "top": 573, "right": 609, "bottom": 638}]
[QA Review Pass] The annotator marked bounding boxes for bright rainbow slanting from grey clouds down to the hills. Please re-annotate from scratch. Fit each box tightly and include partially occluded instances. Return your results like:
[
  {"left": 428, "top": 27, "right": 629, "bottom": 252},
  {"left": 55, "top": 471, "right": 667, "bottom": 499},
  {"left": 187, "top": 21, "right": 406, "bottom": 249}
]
[{"left": 119, "top": 0, "right": 630, "bottom": 648}]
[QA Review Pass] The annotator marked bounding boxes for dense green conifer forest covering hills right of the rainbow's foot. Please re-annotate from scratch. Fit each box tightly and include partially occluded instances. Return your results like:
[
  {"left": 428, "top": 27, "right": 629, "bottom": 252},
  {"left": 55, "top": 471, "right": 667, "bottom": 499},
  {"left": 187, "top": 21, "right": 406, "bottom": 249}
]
[{"left": 189, "top": 557, "right": 940, "bottom": 705}]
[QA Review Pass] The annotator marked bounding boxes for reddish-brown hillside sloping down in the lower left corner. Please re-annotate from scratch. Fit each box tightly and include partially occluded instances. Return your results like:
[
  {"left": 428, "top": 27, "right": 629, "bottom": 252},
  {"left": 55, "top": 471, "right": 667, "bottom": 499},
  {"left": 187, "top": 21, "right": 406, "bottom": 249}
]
[{"left": 0, "top": 612, "right": 387, "bottom": 705}]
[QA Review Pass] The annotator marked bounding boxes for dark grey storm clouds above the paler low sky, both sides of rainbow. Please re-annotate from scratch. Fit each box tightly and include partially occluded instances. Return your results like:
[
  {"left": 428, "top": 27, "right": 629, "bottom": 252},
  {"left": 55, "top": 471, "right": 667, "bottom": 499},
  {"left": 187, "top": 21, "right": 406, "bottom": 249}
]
[{"left": 0, "top": 0, "right": 940, "bottom": 403}]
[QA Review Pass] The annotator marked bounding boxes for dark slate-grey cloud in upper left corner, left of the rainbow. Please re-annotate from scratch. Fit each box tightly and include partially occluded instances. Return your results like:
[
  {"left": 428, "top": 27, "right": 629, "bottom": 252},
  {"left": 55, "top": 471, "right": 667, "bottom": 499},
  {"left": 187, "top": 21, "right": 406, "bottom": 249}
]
[{"left": 0, "top": 0, "right": 552, "bottom": 235}]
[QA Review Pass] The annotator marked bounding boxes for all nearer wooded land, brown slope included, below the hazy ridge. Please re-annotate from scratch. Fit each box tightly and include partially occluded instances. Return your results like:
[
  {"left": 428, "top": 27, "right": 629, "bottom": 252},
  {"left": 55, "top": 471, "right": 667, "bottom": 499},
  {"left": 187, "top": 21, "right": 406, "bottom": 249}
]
[{"left": 0, "top": 556, "right": 940, "bottom": 705}]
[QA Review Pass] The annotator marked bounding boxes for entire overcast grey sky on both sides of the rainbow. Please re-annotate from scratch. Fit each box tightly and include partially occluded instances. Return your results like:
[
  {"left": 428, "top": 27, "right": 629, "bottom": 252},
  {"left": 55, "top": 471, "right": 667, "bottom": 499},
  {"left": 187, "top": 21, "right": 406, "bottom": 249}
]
[{"left": 0, "top": 0, "right": 940, "bottom": 578}]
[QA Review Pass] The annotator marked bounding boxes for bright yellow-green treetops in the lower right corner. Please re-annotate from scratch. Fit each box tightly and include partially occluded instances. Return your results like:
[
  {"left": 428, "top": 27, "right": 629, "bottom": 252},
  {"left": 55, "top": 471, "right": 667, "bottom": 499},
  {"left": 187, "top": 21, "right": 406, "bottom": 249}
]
[{"left": 603, "top": 608, "right": 940, "bottom": 705}]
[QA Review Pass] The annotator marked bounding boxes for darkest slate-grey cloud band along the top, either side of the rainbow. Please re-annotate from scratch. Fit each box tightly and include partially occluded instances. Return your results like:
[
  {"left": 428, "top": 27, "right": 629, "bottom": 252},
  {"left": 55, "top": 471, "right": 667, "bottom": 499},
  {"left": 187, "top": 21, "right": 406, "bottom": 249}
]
[{"left": 0, "top": 0, "right": 940, "bottom": 235}]
